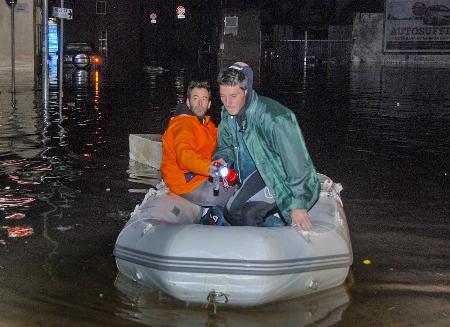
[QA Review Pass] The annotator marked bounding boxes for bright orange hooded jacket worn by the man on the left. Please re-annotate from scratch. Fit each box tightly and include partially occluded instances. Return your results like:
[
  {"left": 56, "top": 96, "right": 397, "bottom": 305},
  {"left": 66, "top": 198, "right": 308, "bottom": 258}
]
[{"left": 161, "top": 107, "right": 217, "bottom": 194}]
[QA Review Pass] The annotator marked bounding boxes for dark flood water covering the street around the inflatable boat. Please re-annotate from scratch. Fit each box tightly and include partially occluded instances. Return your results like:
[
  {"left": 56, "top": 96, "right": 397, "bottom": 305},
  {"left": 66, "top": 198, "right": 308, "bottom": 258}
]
[{"left": 0, "top": 60, "right": 450, "bottom": 326}]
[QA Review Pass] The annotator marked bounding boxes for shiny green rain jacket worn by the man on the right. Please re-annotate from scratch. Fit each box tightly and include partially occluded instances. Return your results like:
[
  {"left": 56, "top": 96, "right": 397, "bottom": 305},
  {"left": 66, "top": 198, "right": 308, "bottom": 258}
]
[{"left": 214, "top": 91, "right": 320, "bottom": 224}]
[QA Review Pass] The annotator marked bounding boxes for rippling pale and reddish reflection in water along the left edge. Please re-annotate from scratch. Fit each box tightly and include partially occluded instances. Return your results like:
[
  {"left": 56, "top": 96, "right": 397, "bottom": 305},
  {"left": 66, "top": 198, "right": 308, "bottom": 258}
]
[{"left": 0, "top": 84, "right": 45, "bottom": 254}]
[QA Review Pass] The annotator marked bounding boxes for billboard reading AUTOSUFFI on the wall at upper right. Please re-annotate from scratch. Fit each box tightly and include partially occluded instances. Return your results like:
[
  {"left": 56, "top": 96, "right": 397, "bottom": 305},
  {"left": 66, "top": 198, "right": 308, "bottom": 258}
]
[{"left": 384, "top": 0, "right": 450, "bottom": 52}]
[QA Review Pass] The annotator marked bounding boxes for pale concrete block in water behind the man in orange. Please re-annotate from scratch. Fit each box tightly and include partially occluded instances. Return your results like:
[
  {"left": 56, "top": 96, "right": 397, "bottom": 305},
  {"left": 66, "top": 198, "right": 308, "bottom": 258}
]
[{"left": 129, "top": 134, "right": 162, "bottom": 169}]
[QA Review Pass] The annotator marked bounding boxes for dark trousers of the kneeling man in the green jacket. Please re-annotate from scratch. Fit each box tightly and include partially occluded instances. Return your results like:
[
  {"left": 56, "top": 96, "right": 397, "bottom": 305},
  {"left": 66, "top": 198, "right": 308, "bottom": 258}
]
[{"left": 224, "top": 170, "right": 277, "bottom": 226}]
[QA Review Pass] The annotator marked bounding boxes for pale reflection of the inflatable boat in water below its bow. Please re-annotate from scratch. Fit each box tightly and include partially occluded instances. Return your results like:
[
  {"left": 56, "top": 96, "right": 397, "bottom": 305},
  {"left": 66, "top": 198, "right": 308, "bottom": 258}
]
[{"left": 114, "top": 274, "right": 349, "bottom": 327}]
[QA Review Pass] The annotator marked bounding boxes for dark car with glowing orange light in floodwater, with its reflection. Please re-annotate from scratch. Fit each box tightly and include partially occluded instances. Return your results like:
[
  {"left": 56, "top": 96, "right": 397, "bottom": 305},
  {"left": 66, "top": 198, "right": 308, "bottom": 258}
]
[{"left": 63, "top": 42, "right": 103, "bottom": 86}]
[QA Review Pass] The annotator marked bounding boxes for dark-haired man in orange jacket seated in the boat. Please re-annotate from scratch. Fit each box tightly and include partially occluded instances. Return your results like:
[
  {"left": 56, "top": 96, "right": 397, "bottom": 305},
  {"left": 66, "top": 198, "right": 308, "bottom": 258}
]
[{"left": 161, "top": 81, "right": 233, "bottom": 207}]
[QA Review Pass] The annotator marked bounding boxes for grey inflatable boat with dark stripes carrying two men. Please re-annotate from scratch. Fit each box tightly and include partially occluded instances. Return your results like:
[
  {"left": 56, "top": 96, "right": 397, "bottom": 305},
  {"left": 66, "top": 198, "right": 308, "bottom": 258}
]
[{"left": 114, "top": 174, "right": 353, "bottom": 306}]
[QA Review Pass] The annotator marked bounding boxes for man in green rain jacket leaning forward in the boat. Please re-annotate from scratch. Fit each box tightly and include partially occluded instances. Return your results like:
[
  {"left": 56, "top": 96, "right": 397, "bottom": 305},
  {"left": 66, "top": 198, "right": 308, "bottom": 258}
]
[{"left": 214, "top": 62, "right": 320, "bottom": 230}]
